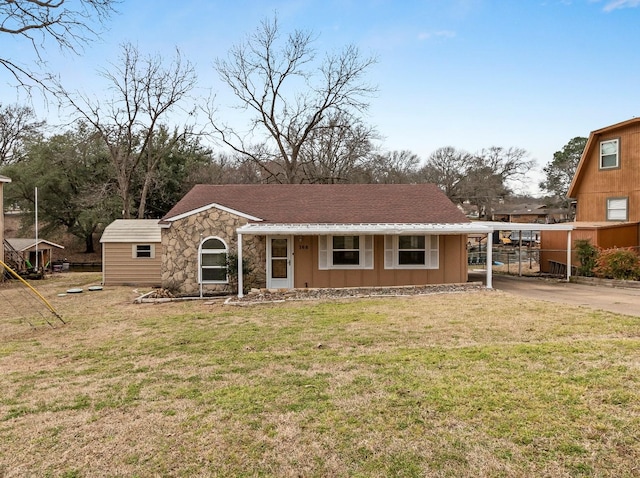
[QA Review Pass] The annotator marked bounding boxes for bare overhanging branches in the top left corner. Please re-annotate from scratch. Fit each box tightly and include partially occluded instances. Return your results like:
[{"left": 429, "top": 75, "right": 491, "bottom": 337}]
[{"left": 0, "top": 0, "right": 118, "bottom": 87}]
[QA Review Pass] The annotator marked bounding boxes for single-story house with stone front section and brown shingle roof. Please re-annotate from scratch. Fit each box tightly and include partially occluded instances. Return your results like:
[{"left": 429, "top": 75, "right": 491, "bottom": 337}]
[{"left": 160, "top": 184, "right": 491, "bottom": 295}]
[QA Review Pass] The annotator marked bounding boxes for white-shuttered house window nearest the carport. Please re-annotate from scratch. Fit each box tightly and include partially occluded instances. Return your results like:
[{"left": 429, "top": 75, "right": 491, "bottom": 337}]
[{"left": 384, "top": 235, "right": 440, "bottom": 269}]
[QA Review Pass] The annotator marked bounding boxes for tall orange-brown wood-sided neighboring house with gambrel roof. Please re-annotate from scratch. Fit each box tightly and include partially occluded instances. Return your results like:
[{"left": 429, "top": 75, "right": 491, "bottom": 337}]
[{"left": 541, "top": 118, "right": 640, "bottom": 271}]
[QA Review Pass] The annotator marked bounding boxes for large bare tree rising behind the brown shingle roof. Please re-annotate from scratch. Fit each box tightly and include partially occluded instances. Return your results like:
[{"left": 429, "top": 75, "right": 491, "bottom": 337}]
[{"left": 209, "top": 14, "right": 376, "bottom": 183}]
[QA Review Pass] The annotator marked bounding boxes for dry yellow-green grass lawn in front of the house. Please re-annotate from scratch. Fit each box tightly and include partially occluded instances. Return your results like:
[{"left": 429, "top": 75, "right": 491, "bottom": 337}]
[{"left": 0, "top": 274, "right": 640, "bottom": 477}]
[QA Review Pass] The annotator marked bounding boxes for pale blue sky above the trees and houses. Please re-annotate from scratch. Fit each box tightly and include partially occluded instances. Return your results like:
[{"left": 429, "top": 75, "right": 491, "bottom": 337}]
[{"left": 0, "top": 0, "right": 640, "bottom": 192}]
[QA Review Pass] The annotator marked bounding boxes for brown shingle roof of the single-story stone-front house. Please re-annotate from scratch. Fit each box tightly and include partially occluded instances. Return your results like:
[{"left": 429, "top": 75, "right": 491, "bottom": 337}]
[{"left": 163, "top": 184, "right": 469, "bottom": 224}]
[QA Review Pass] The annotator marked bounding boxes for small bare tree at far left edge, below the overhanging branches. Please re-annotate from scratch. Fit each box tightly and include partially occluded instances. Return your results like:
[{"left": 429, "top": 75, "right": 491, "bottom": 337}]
[{"left": 0, "top": 103, "right": 45, "bottom": 167}]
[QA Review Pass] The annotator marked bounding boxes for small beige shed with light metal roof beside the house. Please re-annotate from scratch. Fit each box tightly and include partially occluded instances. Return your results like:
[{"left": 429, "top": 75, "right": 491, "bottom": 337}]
[{"left": 100, "top": 219, "right": 162, "bottom": 287}]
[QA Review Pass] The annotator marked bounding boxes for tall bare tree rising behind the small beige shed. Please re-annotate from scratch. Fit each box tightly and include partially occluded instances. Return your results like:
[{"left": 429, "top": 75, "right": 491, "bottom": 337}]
[{"left": 57, "top": 44, "right": 196, "bottom": 218}]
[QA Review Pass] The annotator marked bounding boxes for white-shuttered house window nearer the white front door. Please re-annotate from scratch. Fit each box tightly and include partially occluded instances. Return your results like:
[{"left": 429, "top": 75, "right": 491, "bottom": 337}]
[{"left": 318, "top": 236, "right": 373, "bottom": 269}]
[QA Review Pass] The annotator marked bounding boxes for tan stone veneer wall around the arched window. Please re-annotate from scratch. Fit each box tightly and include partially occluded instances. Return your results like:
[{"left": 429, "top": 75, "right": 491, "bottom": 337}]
[{"left": 161, "top": 208, "right": 266, "bottom": 295}]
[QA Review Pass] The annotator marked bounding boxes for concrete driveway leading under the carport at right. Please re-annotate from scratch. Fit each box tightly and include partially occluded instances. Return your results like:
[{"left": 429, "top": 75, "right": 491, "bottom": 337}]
[{"left": 469, "top": 273, "right": 640, "bottom": 317}]
